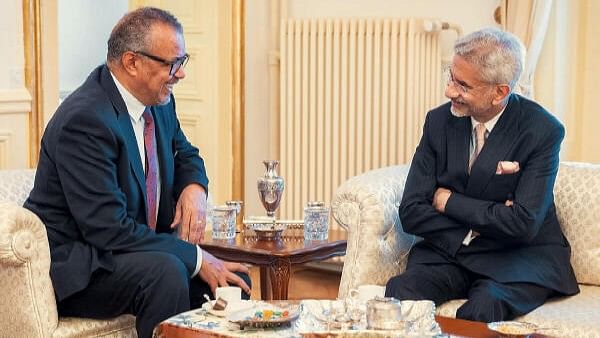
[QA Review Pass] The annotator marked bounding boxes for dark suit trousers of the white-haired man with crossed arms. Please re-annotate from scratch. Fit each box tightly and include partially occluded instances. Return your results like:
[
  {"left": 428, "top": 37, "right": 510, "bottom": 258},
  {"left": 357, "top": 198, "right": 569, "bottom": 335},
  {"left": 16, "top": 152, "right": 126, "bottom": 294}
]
[{"left": 385, "top": 263, "right": 554, "bottom": 323}]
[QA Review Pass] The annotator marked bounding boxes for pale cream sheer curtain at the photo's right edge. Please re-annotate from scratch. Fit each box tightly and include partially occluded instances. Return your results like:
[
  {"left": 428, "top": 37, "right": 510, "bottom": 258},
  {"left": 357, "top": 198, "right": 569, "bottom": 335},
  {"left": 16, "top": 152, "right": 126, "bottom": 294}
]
[{"left": 535, "top": 0, "right": 600, "bottom": 163}]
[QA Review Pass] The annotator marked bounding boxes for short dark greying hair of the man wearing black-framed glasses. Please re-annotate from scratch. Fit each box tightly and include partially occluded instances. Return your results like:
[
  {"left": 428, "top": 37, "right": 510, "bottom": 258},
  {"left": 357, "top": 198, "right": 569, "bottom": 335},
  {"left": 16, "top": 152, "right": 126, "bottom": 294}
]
[{"left": 106, "top": 7, "right": 183, "bottom": 62}]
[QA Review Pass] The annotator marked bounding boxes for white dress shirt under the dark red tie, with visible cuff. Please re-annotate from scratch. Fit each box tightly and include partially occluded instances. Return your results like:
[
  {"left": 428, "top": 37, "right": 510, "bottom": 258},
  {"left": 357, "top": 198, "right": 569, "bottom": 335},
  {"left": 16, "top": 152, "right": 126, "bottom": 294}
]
[{"left": 110, "top": 72, "right": 202, "bottom": 277}]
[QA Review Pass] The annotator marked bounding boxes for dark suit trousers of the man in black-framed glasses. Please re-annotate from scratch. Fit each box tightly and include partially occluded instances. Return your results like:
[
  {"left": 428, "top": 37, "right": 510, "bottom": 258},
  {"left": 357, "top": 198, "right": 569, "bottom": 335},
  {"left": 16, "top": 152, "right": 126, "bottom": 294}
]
[{"left": 57, "top": 251, "right": 251, "bottom": 338}]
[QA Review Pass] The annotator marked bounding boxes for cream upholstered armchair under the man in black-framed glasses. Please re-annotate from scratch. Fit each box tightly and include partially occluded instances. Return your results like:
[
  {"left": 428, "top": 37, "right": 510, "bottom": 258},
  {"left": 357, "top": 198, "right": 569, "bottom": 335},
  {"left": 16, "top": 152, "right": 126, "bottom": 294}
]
[{"left": 0, "top": 170, "right": 137, "bottom": 338}]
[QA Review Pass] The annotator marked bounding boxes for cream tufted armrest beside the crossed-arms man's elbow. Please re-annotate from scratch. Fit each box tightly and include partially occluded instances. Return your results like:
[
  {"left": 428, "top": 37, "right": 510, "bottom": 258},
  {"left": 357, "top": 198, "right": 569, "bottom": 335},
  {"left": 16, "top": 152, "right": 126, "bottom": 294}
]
[{"left": 331, "top": 165, "right": 418, "bottom": 298}]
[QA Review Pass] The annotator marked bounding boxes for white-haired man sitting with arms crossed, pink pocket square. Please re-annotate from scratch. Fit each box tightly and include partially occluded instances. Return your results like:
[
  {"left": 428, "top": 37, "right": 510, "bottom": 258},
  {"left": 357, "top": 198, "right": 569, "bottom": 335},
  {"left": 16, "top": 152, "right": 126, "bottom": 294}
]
[{"left": 386, "top": 28, "right": 579, "bottom": 322}]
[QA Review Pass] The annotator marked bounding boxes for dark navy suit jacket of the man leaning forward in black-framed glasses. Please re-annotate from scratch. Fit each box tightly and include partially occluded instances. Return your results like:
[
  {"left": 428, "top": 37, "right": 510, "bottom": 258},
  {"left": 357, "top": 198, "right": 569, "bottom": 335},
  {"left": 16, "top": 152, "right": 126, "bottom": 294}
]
[{"left": 24, "top": 65, "right": 208, "bottom": 300}]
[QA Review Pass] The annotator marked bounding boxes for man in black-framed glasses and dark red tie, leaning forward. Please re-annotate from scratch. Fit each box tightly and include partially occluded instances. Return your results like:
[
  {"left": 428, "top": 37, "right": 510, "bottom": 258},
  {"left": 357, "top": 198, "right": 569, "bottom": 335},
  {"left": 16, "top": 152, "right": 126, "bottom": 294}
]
[{"left": 24, "top": 7, "right": 250, "bottom": 337}]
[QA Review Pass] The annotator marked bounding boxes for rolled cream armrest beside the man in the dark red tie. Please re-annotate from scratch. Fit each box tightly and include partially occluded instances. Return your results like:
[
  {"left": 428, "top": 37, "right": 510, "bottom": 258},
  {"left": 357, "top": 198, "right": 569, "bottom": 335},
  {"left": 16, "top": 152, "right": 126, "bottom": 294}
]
[{"left": 0, "top": 202, "right": 58, "bottom": 337}]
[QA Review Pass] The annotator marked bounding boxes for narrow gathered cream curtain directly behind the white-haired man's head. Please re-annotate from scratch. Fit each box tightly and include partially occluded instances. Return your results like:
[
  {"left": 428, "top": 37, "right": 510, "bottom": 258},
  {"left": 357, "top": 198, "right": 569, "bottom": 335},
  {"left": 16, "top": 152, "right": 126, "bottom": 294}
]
[{"left": 501, "top": 0, "right": 552, "bottom": 98}]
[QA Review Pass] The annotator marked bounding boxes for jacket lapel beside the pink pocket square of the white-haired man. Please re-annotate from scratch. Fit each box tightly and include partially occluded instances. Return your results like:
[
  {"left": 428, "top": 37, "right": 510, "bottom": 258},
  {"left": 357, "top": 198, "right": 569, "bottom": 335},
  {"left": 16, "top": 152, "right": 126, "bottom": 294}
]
[{"left": 466, "top": 94, "right": 520, "bottom": 196}]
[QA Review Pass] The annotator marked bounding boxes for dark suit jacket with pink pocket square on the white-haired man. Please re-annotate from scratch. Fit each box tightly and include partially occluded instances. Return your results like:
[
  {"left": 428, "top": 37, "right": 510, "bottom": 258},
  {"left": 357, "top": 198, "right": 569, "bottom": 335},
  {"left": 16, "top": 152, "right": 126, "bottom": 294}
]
[{"left": 400, "top": 94, "right": 578, "bottom": 294}]
